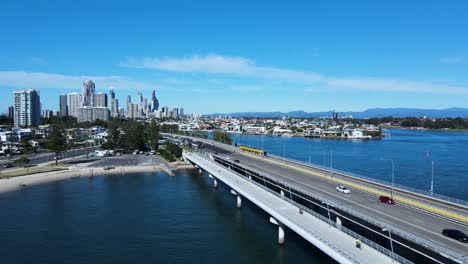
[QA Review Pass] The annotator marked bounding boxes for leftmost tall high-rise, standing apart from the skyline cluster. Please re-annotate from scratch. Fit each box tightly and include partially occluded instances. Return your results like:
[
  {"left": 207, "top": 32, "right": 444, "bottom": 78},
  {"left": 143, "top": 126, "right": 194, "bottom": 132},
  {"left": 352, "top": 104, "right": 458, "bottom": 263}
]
[{"left": 14, "top": 89, "right": 41, "bottom": 126}]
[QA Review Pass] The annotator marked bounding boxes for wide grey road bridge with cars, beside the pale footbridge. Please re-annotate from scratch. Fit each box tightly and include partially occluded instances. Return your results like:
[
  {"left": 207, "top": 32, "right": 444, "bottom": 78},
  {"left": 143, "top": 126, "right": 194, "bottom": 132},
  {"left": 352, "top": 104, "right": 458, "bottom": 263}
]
[{"left": 172, "top": 135, "right": 468, "bottom": 263}]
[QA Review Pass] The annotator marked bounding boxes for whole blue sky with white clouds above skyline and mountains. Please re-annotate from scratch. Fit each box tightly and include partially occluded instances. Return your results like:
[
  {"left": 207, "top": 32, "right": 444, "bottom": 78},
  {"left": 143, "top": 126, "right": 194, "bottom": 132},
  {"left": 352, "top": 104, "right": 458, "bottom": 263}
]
[{"left": 0, "top": 0, "right": 468, "bottom": 113}]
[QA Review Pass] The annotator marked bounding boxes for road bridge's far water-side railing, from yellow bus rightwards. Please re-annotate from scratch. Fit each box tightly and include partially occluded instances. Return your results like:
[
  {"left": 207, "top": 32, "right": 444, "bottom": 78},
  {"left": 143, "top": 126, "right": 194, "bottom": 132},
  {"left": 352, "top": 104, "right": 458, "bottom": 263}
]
[{"left": 268, "top": 154, "right": 468, "bottom": 207}]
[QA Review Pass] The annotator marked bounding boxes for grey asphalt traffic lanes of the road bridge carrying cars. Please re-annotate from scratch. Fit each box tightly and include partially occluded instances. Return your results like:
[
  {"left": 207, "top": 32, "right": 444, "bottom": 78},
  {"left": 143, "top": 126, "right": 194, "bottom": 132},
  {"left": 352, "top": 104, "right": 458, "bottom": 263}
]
[{"left": 224, "top": 153, "right": 468, "bottom": 255}]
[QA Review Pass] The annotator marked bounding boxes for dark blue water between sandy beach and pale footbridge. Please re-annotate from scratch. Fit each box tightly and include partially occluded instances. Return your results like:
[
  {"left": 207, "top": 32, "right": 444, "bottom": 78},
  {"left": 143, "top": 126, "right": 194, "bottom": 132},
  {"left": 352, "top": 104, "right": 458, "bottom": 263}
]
[{"left": 0, "top": 170, "right": 332, "bottom": 264}]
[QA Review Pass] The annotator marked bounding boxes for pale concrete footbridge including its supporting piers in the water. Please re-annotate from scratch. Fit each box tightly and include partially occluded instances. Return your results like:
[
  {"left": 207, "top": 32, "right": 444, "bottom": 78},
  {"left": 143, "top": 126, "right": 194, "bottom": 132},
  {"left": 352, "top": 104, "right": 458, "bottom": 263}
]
[{"left": 183, "top": 152, "right": 409, "bottom": 264}]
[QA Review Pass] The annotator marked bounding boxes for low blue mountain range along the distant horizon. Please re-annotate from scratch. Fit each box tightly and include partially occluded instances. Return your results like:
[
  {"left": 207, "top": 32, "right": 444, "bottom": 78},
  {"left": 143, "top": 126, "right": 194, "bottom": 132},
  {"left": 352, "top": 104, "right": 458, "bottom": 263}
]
[{"left": 205, "top": 107, "right": 468, "bottom": 118}]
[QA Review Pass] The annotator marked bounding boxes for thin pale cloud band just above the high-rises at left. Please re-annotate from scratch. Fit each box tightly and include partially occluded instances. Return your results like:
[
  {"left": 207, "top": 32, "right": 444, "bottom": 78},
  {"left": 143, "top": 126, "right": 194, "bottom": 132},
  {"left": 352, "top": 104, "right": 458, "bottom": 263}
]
[{"left": 0, "top": 71, "right": 156, "bottom": 89}]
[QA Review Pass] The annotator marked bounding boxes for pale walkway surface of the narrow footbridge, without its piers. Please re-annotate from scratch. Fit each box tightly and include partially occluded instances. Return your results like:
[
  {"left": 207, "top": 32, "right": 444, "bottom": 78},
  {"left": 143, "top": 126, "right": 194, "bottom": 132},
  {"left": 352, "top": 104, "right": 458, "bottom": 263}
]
[{"left": 184, "top": 153, "right": 392, "bottom": 263}]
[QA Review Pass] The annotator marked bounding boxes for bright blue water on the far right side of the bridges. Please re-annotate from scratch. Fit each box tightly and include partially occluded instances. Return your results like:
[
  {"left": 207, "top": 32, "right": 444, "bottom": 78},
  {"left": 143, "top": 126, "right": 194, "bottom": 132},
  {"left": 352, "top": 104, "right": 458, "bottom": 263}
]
[{"left": 232, "top": 129, "right": 468, "bottom": 200}]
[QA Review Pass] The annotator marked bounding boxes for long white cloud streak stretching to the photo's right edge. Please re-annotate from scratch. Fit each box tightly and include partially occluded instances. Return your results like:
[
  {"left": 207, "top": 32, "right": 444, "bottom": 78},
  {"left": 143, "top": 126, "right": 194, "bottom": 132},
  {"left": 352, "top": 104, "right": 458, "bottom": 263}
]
[{"left": 121, "top": 54, "right": 468, "bottom": 94}]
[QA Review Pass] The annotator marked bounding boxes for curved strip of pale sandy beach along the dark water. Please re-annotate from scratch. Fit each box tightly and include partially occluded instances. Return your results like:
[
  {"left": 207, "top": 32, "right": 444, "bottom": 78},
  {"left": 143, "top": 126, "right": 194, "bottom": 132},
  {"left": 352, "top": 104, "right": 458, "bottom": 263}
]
[{"left": 0, "top": 164, "right": 194, "bottom": 194}]
